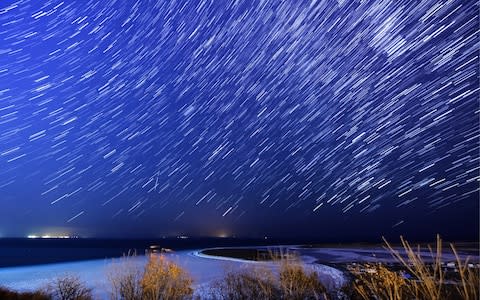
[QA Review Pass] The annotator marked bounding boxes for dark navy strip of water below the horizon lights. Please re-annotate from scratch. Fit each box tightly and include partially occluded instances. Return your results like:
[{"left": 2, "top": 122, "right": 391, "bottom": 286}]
[{"left": 0, "top": 238, "right": 322, "bottom": 267}]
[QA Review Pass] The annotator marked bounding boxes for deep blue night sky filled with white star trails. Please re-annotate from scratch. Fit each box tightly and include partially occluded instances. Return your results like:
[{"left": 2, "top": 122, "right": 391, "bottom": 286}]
[{"left": 0, "top": 0, "right": 480, "bottom": 240}]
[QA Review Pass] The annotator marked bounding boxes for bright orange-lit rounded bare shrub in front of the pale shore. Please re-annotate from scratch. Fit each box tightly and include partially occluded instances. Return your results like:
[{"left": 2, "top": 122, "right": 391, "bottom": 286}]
[{"left": 141, "top": 256, "right": 193, "bottom": 300}]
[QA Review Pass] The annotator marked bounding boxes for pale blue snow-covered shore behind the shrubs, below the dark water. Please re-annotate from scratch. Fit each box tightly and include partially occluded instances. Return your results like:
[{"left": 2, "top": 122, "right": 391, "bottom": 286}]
[{"left": 0, "top": 250, "right": 345, "bottom": 299}]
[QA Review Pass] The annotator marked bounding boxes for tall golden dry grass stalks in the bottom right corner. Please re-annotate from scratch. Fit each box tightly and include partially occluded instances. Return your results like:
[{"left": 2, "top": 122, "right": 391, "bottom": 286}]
[{"left": 354, "top": 236, "right": 480, "bottom": 300}]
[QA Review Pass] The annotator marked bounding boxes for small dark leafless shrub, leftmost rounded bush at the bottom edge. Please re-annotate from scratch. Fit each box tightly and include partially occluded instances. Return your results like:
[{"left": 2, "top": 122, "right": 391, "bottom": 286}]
[{"left": 46, "top": 274, "right": 93, "bottom": 300}]
